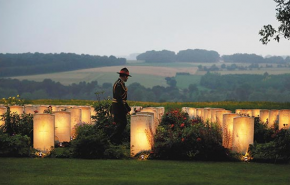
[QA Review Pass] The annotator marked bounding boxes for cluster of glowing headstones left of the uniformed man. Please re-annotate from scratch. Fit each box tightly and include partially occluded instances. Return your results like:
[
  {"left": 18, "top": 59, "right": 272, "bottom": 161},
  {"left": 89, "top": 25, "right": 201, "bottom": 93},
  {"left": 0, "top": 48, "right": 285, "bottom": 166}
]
[{"left": 0, "top": 105, "right": 94, "bottom": 153}]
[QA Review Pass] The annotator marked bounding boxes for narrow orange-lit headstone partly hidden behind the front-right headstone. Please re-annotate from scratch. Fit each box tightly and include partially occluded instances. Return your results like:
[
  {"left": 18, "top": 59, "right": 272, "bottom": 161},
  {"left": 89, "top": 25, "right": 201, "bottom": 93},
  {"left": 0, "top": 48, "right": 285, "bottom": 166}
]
[{"left": 222, "top": 113, "right": 239, "bottom": 149}]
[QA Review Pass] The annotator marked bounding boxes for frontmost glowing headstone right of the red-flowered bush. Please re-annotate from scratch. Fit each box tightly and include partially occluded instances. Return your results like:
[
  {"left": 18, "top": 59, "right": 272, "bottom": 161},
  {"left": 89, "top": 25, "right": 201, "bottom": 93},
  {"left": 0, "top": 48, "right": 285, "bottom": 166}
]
[{"left": 232, "top": 117, "right": 254, "bottom": 155}]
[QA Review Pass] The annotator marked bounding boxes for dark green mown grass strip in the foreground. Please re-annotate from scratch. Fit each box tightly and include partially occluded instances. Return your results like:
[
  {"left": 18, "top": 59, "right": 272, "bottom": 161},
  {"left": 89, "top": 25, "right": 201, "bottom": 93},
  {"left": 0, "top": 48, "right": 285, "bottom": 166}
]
[{"left": 0, "top": 158, "right": 290, "bottom": 185}]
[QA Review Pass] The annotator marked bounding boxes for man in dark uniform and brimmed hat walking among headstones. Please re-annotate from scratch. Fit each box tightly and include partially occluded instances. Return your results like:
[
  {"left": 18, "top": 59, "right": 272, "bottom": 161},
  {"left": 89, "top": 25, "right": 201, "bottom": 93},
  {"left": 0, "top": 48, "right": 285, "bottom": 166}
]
[{"left": 110, "top": 68, "right": 131, "bottom": 144}]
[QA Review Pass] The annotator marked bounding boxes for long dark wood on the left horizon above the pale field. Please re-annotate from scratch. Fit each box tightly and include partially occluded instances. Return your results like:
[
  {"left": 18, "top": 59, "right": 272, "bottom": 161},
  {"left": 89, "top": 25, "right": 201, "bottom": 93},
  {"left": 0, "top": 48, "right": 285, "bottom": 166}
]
[{"left": 0, "top": 53, "right": 126, "bottom": 77}]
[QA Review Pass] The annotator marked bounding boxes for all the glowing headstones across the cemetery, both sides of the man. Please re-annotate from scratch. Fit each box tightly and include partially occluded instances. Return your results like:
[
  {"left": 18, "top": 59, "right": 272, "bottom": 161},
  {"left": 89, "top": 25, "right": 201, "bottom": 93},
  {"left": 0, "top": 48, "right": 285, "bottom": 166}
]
[{"left": 0, "top": 105, "right": 290, "bottom": 155}]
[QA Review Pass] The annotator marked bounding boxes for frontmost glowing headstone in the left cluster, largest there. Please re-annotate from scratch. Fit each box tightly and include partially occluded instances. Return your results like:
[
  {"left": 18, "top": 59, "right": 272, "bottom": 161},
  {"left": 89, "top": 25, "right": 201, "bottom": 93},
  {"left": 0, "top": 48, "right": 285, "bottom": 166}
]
[{"left": 33, "top": 114, "right": 55, "bottom": 153}]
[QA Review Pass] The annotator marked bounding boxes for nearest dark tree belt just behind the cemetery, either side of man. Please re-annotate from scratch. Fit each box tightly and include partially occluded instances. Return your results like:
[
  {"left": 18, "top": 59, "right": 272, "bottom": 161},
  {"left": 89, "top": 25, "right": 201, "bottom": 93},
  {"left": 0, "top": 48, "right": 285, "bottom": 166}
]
[{"left": 0, "top": 72, "right": 290, "bottom": 102}]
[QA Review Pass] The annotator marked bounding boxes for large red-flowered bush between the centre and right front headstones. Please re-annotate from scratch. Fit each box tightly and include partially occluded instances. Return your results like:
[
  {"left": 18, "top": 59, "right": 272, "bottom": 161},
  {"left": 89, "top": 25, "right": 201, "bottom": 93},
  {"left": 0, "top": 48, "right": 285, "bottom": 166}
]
[{"left": 151, "top": 110, "right": 228, "bottom": 160}]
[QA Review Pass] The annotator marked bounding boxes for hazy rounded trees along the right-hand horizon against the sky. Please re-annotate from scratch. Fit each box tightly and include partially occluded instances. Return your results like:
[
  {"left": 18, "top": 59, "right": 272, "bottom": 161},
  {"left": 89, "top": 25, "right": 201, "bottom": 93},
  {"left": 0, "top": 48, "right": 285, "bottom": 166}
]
[{"left": 137, "top": 49, "right": 290, "bottom": 64}]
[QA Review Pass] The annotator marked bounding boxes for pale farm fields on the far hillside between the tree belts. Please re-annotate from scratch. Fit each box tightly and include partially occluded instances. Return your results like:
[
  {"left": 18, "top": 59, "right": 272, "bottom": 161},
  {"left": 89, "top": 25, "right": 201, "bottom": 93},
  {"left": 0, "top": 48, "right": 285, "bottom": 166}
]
[{"left": 6, "top": 61, "right": 289, "bottom": 88}]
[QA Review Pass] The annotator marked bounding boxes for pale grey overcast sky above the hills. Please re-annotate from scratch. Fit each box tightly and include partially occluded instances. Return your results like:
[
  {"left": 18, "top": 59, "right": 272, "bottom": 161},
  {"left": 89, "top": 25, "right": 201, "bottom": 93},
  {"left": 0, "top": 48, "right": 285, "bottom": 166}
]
[{"left": 0, "top": 0, "right": 290, "bottom": 56}]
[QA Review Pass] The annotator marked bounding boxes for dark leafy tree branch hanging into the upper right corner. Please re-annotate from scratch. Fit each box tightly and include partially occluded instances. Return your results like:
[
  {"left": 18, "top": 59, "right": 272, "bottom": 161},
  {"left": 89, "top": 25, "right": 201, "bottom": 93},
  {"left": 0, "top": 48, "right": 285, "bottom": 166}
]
[{"left": 259, "top": 0, "right": 290, "bottom": 44}]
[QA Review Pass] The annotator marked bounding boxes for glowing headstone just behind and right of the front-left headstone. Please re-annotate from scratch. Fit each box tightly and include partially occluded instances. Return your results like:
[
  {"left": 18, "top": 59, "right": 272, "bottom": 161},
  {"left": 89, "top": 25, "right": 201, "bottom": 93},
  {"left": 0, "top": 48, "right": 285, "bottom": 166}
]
[{"left": 53, "top": 111, "right": 71, "bottom": 142}]
